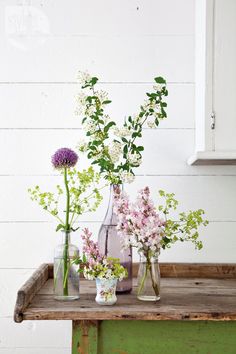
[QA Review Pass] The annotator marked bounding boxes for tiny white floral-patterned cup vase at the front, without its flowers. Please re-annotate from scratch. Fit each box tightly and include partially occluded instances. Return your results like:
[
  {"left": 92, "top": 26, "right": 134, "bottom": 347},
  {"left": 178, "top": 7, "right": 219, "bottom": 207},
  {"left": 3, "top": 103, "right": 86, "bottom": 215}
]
[{"left": 95, "top": 278, "right": 117, "bottom": 305}]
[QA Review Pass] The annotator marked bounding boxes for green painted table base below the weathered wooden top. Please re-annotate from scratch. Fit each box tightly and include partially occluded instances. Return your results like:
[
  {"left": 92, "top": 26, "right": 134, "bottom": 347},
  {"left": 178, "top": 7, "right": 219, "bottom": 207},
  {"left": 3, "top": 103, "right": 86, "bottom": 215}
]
[{"left": 72, "top": 321, "right": 236, "bottom": 354}]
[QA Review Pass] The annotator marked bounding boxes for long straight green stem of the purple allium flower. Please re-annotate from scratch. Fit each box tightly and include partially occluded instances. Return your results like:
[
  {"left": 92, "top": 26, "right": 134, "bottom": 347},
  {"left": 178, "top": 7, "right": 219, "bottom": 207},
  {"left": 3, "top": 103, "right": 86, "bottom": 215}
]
[{"left": 63, "top": 168, "right": 70, "bottom": 296}]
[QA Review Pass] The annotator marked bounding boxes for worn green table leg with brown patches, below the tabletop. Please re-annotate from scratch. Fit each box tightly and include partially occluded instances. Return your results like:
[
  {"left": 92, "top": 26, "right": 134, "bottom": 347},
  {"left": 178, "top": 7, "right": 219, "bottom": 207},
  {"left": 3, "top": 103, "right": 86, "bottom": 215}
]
[{"left": 72, "top": 320, "right": 98, "bottom": 354}]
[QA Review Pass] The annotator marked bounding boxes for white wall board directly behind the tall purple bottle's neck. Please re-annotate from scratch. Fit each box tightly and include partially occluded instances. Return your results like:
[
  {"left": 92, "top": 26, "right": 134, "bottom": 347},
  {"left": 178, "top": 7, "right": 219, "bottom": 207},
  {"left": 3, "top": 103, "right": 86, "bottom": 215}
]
[{"left": 0, "top": 176, "right": 236, "bottom": 222}]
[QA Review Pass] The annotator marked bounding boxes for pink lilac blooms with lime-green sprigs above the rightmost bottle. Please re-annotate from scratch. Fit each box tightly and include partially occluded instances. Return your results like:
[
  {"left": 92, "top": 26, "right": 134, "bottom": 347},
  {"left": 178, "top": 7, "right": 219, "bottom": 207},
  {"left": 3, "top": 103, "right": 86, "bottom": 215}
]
[{"left": 115, "top": 187, "right": 208, "bottom": 259}]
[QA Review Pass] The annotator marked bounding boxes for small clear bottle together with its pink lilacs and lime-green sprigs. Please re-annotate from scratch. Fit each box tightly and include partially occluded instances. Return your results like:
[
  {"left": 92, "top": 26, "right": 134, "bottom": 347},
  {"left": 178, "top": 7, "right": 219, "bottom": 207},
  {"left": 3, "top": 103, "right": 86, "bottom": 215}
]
[{"left": 115, "top": 187, "right": 208, "bottom": 301}]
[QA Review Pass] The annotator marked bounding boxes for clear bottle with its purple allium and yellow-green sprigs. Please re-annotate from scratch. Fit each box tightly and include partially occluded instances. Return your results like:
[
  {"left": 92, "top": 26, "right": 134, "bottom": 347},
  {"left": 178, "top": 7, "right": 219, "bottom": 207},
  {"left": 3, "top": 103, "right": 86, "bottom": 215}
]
[{"left": 29, "top": 148, "right": 102, "bottom": 301}]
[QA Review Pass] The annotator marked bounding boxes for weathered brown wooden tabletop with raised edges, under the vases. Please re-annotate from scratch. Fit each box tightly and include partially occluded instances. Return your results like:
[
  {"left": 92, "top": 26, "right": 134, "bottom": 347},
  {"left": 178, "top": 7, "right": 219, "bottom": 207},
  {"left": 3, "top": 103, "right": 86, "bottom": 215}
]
[{"left": 15, "top": 264, "right": 236, "bottom": 322}]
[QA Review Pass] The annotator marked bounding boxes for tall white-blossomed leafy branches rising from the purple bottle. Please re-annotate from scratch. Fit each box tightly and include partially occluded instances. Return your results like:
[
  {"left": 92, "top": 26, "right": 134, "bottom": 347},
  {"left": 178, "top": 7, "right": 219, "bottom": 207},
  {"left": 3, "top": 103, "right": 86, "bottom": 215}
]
[{"left": 77, "top": 73, "right": 168, "bottom": 184}]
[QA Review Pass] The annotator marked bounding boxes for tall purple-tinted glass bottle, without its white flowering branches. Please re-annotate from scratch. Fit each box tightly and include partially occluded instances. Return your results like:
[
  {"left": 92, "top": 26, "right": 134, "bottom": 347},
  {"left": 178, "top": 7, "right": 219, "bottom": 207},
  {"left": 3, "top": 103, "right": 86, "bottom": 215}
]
[{"left": 98, "top": 184, "right": 132, "bottom": 293}]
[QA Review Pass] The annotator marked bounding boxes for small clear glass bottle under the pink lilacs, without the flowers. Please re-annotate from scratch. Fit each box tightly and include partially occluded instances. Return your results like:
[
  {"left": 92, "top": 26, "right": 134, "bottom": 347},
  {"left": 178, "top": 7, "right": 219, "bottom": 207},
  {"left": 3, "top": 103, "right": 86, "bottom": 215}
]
[{"left": 137, "top": 254, "right": 161, "bottom": 301}]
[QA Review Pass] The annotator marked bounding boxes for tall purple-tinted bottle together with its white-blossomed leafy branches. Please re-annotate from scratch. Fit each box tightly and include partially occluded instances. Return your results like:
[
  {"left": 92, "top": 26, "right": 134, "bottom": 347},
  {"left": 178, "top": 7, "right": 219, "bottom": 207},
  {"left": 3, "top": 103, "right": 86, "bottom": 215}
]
[{"left": 77, "top": 73, "right": 168, "bottom": 292}]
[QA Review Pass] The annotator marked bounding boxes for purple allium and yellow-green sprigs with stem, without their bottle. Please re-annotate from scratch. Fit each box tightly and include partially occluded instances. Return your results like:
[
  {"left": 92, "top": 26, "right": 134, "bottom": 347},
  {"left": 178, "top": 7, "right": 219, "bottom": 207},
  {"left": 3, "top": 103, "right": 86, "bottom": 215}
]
[{"left": 28, "top": 148, "right": 102, "bottom": 297}]
